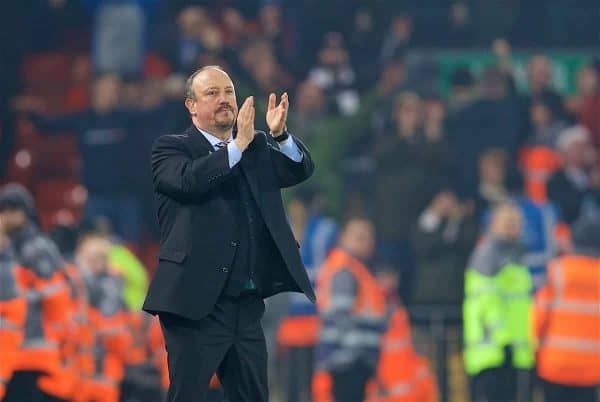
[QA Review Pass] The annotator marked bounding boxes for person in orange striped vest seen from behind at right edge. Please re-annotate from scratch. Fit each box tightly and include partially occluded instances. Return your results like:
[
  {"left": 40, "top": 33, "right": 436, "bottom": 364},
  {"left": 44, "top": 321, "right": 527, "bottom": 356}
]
[{"left": 534, "top": 219, "right": 600, "bottom": 402}]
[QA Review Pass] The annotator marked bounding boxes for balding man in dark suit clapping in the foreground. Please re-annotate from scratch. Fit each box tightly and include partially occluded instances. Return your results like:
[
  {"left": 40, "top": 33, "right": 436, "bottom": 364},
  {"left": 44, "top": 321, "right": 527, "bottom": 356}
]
[{"left": 144, "top": 66, "right": 315, "bottom": 402}]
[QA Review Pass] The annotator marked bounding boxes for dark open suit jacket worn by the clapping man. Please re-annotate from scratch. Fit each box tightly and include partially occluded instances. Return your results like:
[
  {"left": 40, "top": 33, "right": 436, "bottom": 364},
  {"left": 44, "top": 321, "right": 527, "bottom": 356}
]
[{"left": 143, "top": 126, "right": 315, "bottom": 319}]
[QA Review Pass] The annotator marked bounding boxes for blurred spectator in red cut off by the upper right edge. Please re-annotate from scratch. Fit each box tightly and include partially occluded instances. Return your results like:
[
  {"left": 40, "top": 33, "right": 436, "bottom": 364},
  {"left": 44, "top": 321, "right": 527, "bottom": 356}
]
[{"left": 569, "top": 65, "right": 600, "bottom": 150}]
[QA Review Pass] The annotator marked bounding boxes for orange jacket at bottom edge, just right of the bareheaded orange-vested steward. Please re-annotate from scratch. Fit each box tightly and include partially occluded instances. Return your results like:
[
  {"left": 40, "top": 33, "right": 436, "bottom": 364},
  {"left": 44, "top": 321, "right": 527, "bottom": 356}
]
[{"left": 366, "top": 308, "right": 438, "bottom": 402}]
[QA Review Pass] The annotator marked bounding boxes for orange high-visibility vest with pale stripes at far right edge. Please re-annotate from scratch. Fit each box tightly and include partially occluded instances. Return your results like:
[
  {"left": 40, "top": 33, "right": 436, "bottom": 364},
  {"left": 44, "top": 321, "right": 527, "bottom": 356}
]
[{"left": 535, "top": 255, "right": 600, "bottom": 386}]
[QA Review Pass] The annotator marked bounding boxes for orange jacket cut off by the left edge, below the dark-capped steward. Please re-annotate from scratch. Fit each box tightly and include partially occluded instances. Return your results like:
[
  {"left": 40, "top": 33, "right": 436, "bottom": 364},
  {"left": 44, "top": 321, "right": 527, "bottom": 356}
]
[{"left": 0, "top": 260, "right": 27, "bottom": 400}]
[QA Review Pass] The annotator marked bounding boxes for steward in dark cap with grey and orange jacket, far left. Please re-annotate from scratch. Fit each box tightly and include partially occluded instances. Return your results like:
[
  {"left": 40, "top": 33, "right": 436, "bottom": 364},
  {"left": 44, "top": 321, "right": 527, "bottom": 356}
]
[{"left": 0, "top": 184, "right": 73, "bottom": 402}]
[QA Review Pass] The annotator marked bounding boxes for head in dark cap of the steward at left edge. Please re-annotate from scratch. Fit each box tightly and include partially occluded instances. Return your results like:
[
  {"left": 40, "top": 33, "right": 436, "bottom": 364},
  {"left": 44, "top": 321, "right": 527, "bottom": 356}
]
[{"left": 0, "top": 183, "right": 36, "bottom": 234}]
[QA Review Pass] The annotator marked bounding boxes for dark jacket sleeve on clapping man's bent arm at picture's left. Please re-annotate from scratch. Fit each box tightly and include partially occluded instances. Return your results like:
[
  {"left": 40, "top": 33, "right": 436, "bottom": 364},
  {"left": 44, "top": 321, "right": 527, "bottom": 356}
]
[{"left": 151, "top": 135, "right": 231, "bottom": 200}]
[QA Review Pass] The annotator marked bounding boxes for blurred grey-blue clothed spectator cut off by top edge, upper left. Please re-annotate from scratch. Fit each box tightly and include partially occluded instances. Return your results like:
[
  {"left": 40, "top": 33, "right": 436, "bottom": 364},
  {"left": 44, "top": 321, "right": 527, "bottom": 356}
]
[{"left": 87, "top": 0, "right": 156, "bottom": 75}]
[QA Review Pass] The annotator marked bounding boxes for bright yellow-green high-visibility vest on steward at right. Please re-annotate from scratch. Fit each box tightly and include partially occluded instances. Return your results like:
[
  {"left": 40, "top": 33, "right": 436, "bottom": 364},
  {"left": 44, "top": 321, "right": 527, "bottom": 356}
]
[{"left": 463, "top": 263, "right": 534, "bottom": 375}]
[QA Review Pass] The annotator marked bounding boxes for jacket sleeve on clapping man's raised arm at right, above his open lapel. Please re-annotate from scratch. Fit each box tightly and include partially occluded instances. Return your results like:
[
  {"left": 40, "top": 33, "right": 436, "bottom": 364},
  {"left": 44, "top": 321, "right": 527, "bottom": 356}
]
[{"left": 263, "top": 134, "right": 315, "bottom": 188}]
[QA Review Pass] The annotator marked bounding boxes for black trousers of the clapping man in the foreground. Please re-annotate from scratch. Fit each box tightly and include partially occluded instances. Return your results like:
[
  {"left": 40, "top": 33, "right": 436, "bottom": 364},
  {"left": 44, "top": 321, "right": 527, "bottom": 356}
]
[{"left": 159, "top": 294, "right": 269, "bottom": 402}]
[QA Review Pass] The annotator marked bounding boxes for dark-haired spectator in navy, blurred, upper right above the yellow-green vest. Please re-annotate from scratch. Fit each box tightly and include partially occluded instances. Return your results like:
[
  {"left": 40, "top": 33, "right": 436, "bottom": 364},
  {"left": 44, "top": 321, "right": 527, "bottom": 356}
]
[{"left": 450, "top": 68, "right": 520, "bottom": 195}]
